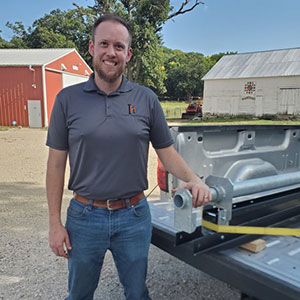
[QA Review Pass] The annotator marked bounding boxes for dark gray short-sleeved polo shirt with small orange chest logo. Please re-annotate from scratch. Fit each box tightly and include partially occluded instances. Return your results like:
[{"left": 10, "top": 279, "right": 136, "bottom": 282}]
[{"left": 46, "top": 75, "right": 173, "bottom": 199}]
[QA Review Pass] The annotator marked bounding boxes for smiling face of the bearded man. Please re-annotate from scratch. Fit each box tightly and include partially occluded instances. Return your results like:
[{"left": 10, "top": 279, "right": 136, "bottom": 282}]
[{"left": 89, "top": 21, "right": 132, "bottom": 83}]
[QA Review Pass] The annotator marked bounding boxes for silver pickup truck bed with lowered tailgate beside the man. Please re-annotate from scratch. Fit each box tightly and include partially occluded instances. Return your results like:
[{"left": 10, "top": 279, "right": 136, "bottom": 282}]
[{"left": 150, "top": 125, "right": 300, "bottom": 300}]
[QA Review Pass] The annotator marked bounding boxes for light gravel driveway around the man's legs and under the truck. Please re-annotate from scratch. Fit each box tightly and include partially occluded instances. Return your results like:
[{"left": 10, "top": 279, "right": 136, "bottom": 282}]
[{"left": 0, "top": 128, "right": 240, "bottom": 300}]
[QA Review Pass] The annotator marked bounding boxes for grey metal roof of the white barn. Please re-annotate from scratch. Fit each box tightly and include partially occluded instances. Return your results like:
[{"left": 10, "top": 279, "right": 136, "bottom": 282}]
[{"left": 202, "top": 48, "right": 300, "bottom": 80}]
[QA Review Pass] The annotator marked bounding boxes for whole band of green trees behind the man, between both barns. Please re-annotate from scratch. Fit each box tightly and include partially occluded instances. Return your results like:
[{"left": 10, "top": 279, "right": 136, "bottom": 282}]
[{"left": 0, "top": 0, "right": 229, "bottom": 96}]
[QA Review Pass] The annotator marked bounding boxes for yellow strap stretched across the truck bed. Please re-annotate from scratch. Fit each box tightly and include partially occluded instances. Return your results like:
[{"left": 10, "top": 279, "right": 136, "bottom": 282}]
[{"left": 202, "top": 220, "right": 300, "bottom": 236}]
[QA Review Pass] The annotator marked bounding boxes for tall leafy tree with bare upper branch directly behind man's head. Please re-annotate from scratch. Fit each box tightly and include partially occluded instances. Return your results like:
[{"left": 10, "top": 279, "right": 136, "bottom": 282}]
[{"left": 75, "top": 0, "right": 202, "bottom": 94}]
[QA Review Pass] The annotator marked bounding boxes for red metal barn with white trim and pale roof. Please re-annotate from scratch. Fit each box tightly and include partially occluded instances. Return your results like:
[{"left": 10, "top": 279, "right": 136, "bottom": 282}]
[{"left": 0, "top": 49, "right": 92, "bottom": 127}]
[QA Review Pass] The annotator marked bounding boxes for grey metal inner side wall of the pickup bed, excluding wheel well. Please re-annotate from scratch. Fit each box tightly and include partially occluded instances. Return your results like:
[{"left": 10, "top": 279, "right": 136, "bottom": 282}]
[{"left": 171, "top": 125, "right": 300, "bottom": 186}]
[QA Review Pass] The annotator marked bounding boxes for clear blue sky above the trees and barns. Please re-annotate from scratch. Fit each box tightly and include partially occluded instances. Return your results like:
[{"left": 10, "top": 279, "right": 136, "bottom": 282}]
[{"left": 0, "top": 0, "right": 300, "bottom": 55}]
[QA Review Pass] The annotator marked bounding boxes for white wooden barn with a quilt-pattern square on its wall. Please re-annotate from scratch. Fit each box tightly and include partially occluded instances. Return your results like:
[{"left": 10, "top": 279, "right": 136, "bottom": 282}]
[{"left": 202, "top": 48, "right": 300, "bottom": 116}]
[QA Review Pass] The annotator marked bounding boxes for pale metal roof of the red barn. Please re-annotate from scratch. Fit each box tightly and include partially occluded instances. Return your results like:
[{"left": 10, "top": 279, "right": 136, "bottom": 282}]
[{"left": 0, "top": 48, "right": 76, "bottom": 66}]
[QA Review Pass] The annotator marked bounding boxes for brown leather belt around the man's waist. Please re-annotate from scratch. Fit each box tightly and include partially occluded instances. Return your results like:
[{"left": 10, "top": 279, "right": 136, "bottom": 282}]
[{"left": 74, "top": 192, "right": 145, "bottom": 210}]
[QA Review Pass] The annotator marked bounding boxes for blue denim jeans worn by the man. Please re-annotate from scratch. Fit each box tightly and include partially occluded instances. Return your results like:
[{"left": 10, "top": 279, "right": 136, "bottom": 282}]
[{"left": 66, "top": 198, "right": 152, "bottom": 300}]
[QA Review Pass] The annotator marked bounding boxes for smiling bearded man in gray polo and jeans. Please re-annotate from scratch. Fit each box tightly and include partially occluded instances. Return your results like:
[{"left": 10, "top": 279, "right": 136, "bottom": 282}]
[{"left": 46, "top": 15, "right": 211, "bottom": 300}]
